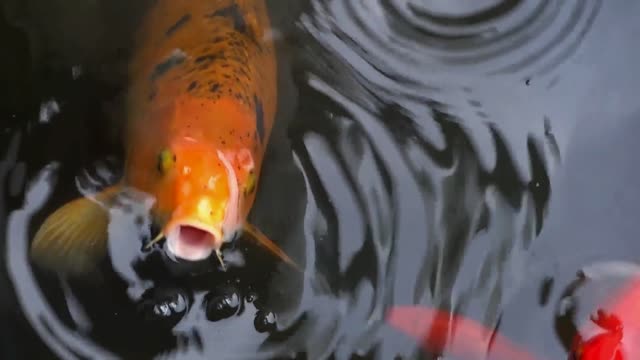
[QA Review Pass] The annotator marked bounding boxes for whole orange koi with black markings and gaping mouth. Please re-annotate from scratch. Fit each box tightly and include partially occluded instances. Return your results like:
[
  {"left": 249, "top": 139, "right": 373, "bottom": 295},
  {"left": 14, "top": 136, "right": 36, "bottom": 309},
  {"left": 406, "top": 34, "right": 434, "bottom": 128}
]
[{"left": 31, "top": 0, "right": 294, "bottom": 273}]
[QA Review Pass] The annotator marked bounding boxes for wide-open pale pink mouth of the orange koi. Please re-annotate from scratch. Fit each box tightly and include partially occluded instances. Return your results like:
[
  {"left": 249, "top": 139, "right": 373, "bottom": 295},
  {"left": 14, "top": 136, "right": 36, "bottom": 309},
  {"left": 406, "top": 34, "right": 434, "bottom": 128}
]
[{"left": 167, "top": 224, "right": 222, "bottom": 261}]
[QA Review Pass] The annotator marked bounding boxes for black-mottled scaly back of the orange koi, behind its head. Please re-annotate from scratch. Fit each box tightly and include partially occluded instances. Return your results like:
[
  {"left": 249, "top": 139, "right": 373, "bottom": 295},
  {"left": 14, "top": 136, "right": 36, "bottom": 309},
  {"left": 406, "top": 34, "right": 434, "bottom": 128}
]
[{"left": 132, "top": 0, "right": 277, "bottom": 152}]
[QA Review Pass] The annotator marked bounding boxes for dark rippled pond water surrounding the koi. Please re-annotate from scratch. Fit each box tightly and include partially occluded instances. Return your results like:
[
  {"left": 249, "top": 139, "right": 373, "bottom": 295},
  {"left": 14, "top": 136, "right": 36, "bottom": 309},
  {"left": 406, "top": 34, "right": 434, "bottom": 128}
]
[{"left": 0, "top": 0, "right": 640, "bottom": 359}]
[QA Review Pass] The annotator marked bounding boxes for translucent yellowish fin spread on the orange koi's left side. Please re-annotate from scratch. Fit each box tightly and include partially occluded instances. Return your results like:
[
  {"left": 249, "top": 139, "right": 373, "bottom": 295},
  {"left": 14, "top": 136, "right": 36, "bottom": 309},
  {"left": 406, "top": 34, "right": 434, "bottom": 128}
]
[{"left": 31, "top": 186, "right": 119, "bottom": 275}]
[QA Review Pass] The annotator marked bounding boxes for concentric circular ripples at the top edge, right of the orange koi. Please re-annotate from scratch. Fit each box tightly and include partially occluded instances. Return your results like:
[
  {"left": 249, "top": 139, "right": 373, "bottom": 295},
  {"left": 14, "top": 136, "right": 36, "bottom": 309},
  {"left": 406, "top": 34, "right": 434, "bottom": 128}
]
[{"left": 303, "top": 0, "right": 602, "bottom": 78}]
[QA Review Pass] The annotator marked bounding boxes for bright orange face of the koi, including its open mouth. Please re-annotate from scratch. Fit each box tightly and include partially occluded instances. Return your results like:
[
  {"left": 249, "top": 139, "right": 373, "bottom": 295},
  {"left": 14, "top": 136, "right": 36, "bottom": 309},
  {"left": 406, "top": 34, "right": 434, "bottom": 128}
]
[{"left": 156, "top": 139, "right": 242, "bottom": 261}]
